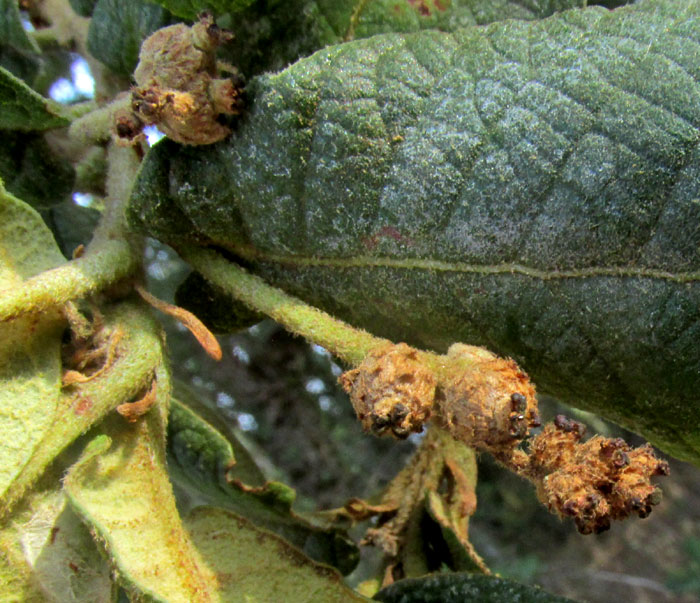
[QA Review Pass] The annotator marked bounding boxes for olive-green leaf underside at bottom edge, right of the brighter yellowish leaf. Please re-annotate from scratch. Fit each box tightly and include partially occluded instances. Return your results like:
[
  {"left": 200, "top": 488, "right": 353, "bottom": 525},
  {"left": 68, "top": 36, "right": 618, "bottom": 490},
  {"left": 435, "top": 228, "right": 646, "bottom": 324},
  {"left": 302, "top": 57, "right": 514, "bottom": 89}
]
[{"left": 185, "top": 507, "right": 367, "bottom": 603}]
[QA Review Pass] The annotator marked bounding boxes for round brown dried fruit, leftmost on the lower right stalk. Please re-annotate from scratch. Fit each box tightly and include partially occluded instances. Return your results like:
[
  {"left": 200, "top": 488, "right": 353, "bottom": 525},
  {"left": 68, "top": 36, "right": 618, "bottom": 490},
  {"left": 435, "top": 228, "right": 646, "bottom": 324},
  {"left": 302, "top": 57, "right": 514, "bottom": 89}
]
[{"left": 340, "top": 343, "right": 437, "bottom": 438}]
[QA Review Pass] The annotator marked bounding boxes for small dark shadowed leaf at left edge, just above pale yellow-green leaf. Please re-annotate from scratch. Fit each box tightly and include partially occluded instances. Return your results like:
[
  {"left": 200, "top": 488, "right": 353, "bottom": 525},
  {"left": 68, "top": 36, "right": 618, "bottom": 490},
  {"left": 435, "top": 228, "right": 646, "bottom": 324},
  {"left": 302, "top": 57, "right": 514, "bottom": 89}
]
[{"left": 0, "top": 131, "right": 75, "bottom": 208}]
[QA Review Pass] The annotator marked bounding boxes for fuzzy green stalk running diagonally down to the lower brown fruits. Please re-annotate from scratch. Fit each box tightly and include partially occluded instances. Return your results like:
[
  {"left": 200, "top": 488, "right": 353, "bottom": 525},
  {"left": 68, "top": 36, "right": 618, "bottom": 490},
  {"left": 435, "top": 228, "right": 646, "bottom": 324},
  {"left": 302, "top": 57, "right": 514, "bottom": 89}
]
[{"left": 178, "top": 246, "right": 390, "bottom": 366}]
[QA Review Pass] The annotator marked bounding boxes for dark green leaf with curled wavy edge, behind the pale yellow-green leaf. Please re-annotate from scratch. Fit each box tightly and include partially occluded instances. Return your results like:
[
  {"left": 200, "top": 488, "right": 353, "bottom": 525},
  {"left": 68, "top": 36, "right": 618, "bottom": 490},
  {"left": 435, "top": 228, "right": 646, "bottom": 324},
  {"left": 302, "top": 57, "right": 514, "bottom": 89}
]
[{"left": 168, "top": 386, "right": 359, "bottom": 574}]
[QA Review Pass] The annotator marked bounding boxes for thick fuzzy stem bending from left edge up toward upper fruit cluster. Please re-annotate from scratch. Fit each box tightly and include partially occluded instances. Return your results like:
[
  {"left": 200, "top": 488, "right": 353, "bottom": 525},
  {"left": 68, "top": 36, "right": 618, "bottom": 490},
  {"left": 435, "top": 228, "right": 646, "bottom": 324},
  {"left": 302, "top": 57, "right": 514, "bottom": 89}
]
[{"left": 0, "top": 146, "right": 141, "bottom": 322}]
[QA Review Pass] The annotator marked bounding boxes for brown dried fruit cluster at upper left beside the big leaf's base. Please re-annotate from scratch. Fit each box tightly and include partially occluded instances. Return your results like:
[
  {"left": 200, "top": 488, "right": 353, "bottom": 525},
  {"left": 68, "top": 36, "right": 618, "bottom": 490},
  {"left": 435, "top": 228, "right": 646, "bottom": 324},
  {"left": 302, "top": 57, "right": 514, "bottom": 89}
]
[{"left": 121, "top": 15, "right": 247, "bottom": 145}]
